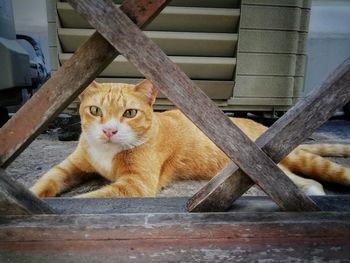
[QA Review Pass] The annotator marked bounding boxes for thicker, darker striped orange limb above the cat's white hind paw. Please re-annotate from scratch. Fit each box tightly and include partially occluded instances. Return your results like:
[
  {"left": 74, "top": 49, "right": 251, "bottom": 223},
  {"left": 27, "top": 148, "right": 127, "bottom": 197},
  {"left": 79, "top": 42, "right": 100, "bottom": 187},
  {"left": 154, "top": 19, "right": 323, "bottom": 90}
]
[{"left": 281, "top": 150, "right": 350, "bottom": 186}]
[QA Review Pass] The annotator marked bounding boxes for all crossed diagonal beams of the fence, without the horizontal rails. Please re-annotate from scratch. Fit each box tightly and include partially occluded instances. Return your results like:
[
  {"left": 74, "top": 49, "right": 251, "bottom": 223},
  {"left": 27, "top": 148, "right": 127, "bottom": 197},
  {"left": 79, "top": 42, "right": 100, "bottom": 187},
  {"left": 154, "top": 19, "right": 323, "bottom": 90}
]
[{"left": 0, "top": 0, "right": 350, "bottom": 216}]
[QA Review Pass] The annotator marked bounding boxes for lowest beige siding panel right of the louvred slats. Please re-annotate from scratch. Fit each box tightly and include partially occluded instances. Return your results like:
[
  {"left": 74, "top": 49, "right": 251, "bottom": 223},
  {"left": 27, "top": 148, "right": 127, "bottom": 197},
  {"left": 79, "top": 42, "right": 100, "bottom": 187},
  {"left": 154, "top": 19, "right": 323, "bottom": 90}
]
[{"left": 233, "top": 75, "right": 294, "bottom": 98}]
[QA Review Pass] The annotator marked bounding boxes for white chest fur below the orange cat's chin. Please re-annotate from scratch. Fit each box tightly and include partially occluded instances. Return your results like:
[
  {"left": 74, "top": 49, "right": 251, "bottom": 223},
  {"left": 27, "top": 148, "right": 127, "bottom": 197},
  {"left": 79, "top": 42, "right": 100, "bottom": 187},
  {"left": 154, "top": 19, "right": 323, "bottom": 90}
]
[{"left": 88, "top": 142, "right": 122, "bottom": 181}]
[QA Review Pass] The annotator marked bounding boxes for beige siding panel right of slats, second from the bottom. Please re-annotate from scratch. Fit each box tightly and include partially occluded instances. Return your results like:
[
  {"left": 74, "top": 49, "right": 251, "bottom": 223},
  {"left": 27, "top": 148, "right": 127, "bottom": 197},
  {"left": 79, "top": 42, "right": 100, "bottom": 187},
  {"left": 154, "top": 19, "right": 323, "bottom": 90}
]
[{"left": 236, "top": 52, "right": 297, "bottom": 76}]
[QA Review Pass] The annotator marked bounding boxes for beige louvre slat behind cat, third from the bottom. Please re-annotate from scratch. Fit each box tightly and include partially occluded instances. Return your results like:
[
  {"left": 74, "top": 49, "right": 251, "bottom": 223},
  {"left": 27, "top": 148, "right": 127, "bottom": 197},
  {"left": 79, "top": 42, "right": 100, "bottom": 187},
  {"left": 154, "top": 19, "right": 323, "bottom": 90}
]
[{"left": 58, "top": 28, "right": 237, "bottom": 57}]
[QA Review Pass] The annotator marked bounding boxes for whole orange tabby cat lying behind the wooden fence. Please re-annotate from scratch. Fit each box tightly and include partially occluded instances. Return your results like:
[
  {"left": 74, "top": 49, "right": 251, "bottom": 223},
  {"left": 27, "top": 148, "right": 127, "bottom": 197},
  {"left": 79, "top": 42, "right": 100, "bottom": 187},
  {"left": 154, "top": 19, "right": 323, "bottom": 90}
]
[{"left": 31, "top": 80, "right": 350, "bottom": 197}]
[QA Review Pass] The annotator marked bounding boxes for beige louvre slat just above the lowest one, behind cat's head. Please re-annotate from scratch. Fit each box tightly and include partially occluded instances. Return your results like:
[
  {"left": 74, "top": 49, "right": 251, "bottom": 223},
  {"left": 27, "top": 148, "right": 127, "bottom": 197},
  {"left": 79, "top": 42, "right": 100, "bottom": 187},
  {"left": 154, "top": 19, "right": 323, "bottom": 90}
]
[{"left": 59, "top": 54, "right": 236, "bottom": 80}]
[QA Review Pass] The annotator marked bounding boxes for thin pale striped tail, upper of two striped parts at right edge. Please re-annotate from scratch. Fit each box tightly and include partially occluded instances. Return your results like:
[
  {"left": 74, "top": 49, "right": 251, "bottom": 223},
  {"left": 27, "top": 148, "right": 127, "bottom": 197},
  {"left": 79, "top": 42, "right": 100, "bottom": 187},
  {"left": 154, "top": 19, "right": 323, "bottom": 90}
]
[{"left": 297, "top": 143, "right": 350, "bottom": 157}]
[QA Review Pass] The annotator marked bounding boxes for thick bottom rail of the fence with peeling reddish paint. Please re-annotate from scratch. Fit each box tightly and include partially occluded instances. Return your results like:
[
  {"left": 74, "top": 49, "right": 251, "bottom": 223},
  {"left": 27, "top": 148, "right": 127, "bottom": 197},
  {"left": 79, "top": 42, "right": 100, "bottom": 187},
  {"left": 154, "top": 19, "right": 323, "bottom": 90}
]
[{"left": 0, "top": 212, "right": 350, "bottom": 262}]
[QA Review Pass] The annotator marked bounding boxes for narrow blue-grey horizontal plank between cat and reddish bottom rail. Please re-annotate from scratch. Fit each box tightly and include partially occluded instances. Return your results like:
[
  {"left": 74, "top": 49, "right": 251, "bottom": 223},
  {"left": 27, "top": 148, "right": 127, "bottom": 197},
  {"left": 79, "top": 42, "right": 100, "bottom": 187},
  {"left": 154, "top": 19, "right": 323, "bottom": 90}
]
[{"left": 44, "top": 195, "right": 350, "bottom": 214}]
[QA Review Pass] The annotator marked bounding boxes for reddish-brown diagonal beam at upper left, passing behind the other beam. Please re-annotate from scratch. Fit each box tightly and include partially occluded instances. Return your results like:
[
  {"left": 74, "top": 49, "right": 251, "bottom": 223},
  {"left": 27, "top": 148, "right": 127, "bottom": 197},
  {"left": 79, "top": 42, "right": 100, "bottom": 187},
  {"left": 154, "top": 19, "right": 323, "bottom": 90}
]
[{"left": 0, "top": 0, "right": 168, "bottom": 168}]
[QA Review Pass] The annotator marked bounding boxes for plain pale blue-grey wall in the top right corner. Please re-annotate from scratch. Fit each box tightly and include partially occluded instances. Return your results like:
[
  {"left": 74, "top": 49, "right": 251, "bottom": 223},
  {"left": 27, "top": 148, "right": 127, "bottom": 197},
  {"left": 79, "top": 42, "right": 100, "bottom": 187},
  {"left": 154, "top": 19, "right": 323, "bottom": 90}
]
[{"left": 305, "top": 0, "right": 350, "bottom": 93}]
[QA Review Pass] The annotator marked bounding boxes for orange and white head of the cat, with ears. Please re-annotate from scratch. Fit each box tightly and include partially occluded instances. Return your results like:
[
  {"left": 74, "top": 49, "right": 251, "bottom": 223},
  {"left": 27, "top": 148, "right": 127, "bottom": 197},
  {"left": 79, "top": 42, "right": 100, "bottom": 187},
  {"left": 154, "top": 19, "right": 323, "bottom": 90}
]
[{"left": 80, "top": 80, "right": 157, "bottom": 149}]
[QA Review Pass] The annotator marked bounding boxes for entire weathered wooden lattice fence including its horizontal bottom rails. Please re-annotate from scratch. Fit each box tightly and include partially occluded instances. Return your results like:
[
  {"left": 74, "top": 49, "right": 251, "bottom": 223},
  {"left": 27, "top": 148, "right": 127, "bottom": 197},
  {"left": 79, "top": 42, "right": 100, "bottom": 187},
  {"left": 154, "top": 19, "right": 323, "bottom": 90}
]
[{"left": 0, "top": 0, "right": 350, "bottom": 262}]
